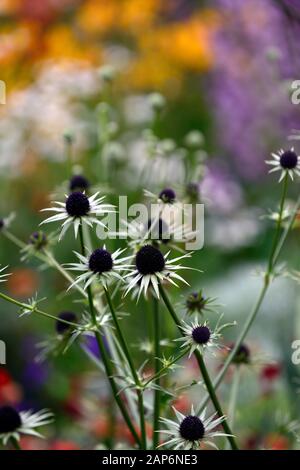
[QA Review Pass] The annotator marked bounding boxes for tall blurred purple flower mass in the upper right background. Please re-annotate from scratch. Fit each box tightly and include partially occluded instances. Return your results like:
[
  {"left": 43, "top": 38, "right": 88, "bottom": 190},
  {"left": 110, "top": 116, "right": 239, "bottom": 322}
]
[{"left": 212, "top": 0, "right": 300, "bottom": 179}]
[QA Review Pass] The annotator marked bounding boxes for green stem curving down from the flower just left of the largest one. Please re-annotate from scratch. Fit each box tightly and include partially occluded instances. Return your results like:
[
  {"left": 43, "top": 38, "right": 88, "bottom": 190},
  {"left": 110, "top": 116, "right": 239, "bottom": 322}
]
[{"left": 104, "top": 287, "right": 147, "bottom": 449}]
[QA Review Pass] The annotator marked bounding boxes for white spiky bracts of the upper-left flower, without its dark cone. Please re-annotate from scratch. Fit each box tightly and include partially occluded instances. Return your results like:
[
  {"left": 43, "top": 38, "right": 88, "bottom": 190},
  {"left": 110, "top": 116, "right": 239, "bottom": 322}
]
[{"left": 40, "top": 192, "right": 115, "bottom": 240}]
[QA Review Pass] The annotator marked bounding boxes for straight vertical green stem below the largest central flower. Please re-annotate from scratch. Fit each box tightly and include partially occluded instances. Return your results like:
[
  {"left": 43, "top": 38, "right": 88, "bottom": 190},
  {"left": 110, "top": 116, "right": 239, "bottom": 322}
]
[{"left": 153, "top": 297, "right": 161, "bottom": 449}]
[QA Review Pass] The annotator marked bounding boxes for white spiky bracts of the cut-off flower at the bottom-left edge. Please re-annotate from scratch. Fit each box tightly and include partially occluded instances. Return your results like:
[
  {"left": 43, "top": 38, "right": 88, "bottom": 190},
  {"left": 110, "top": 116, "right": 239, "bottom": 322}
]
[{"left": 0, "top": 409, "right": 54, "bottom": 445}]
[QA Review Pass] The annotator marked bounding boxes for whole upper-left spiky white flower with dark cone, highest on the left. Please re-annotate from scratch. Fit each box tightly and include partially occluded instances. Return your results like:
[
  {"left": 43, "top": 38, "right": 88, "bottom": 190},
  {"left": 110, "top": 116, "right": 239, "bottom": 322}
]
[{"left": 42, "top": 191, "right": 115, "bottom": 239}]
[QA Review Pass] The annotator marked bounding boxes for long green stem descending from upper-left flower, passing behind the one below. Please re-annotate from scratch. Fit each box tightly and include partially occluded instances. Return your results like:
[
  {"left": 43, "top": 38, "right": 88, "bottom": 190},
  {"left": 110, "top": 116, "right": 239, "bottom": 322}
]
[{"left": 79, "top": 225, "right": 142, "bottom": 448}]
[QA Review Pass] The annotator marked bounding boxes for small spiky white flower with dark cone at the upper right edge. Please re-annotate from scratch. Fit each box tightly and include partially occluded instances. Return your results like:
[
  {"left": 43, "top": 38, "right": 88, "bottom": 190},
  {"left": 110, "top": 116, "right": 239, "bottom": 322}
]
[{"left": 266, "top": 148, "right": 300, "bottom": 183}]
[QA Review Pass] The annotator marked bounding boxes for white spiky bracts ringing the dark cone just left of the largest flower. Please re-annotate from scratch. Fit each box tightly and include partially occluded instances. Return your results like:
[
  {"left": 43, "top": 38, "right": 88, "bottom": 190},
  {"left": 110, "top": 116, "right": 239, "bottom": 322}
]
[{"left": 66, "top": 245, "right": 132, "bottom": 290}]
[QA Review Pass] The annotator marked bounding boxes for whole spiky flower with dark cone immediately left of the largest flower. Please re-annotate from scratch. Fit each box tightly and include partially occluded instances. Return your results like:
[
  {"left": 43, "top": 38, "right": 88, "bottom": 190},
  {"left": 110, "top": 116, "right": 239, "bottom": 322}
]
[{"left": 67, "top": 246, "right": 132, "bottom": 289}]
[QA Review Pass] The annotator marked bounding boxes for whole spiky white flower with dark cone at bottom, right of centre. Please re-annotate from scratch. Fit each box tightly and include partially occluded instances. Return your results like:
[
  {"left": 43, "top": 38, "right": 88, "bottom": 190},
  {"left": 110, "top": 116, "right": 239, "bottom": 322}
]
[{"left": 159, "top": 406, "right": 228, "bottom": 450}]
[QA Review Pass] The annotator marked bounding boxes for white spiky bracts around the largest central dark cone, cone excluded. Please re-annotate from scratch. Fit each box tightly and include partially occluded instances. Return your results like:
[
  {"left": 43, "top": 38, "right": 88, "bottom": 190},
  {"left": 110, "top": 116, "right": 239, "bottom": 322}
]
[{"left": 124, "top": 245, "right": 194, "bottom": 300}]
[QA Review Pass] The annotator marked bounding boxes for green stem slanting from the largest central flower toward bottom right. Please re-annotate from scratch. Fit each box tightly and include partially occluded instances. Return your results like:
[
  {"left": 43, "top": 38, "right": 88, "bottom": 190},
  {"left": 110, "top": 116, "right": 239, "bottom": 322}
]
[{"left": 159, "top": 284, "right": 238, "bottom": 450}]
